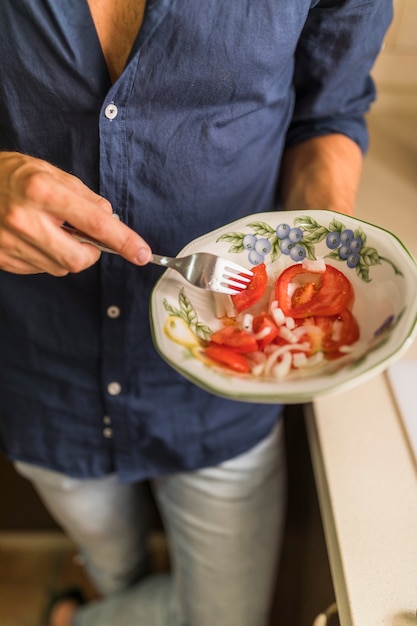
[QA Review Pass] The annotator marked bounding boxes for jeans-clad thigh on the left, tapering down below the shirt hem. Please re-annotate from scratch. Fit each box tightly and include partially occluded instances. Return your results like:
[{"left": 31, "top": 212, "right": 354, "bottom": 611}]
[{"left": 15, "top": 463, "right": 153, "bottom": 595}]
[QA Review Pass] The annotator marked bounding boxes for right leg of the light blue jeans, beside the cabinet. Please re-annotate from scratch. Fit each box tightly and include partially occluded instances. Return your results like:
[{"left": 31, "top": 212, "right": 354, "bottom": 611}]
[{"left": 153, "top": 414, "right": 286, "bottom": 626}]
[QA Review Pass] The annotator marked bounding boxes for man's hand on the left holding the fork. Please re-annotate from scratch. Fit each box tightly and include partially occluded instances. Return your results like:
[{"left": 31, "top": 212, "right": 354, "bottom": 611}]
[{"left": 0, "top": 152, "right": 151, "bottom": 276}]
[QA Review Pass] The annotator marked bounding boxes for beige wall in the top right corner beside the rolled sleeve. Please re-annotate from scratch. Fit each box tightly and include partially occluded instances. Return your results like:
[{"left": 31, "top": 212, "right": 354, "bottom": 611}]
[{"left": 373, "top": 0, "right": 417, "bottom": 113}]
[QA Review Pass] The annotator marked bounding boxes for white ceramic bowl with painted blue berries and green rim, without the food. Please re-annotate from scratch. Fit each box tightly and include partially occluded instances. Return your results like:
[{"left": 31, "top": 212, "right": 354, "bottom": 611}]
[{"left": 150, "top": 210, "right": 417, "bottom": 404}]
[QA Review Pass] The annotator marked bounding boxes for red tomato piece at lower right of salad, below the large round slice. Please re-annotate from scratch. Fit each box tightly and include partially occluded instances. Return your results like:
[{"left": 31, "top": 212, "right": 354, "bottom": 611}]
[{"left": 315, "top": 309, "right": 359, "bottom": 359}]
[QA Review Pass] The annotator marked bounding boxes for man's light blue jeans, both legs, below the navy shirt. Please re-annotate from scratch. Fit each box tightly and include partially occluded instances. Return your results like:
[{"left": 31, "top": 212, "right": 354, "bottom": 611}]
[{"left": 16, "top": 421, "right": 286, "bottom": 626}]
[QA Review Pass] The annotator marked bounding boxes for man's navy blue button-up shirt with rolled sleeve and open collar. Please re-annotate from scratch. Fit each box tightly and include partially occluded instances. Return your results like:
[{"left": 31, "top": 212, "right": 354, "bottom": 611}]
[{"left": 0, "top": 0, "right": 392, "bottom": 481}]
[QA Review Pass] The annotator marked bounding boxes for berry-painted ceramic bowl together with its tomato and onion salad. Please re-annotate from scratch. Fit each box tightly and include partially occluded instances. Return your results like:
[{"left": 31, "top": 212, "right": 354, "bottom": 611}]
[{"left": 150, "top": 210, "right": 417, "bottom": 404}]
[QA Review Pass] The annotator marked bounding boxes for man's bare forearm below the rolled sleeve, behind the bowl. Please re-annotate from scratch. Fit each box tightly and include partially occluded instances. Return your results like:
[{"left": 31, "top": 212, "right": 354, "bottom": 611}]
[{"left": 280, "top": 134, "right": 363, "bottom": 215}]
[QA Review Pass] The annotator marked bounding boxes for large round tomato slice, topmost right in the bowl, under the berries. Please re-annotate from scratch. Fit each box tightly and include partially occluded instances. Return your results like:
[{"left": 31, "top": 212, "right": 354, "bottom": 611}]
[{"left": 275, "top": 264, "right": 353, "bottom": 319}]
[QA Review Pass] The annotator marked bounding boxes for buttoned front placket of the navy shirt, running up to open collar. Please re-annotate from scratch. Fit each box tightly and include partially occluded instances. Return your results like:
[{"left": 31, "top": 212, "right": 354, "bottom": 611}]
[{"left": 94, "top": 0, "right": 172, "bottom": 473}]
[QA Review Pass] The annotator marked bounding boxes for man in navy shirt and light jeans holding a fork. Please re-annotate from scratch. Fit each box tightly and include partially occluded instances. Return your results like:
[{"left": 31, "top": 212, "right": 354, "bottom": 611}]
[{"left": 0, "top": 0, "right": 392, "bottom": 626}]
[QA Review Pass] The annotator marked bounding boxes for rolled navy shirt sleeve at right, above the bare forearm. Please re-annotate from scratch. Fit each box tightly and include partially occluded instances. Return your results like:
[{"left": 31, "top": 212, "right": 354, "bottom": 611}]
[{"left": 286, "top": 0, "right": 393, "bottom": 152}]
